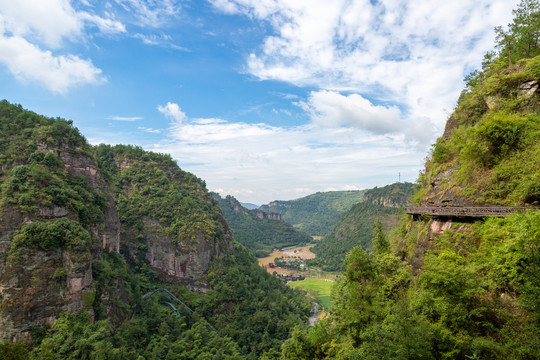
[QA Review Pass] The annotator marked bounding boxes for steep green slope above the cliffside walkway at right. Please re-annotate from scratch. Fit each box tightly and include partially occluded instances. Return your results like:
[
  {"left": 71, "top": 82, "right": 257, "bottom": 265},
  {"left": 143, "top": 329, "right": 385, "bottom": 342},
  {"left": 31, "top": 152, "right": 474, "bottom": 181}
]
[{"left": 420, "top": 0, "right": 540, "bottom": 205}]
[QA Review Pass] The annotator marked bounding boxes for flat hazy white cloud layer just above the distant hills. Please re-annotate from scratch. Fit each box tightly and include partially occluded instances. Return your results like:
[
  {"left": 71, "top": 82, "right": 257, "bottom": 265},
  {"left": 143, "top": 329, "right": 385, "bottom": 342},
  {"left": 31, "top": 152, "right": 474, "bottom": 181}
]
[{"left": 148, "top": 103, "right": 425, "bottom": 203}]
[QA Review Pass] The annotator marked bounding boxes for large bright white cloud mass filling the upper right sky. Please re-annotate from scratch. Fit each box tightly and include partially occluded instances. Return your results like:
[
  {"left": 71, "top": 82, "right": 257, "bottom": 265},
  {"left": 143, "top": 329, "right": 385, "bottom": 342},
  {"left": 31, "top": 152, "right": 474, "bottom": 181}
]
[{"left": 210, "top": 0, "right": 517, "bottom": 143}]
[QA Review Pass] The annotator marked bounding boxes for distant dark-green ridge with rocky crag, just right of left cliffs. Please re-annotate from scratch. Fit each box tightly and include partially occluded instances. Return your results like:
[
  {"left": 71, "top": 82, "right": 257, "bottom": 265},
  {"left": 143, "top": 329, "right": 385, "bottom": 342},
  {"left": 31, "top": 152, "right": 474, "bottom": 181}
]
[{"left": 212, "top": 193, "right": 312, "bottom": 257}]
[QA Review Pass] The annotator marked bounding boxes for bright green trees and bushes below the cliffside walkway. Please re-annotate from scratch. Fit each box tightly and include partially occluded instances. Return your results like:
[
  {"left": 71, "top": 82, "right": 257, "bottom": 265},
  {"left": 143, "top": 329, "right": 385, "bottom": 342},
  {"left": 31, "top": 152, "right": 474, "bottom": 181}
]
[{"left": 282, "top": 212, "right": 540, "bottom": 359}]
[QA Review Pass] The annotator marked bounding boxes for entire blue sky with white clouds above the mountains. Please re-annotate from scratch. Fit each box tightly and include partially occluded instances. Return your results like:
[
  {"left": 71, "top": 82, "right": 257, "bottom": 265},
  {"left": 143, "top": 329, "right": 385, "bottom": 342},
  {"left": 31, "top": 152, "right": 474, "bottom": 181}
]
[{"left": 0, "top": 0, "right": 518, "bottom": 204}]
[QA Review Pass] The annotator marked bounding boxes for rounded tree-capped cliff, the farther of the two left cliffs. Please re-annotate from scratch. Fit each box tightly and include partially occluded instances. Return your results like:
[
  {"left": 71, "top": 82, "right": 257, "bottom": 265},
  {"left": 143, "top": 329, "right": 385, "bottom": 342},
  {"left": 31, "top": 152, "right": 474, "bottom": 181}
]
[{"left": 101, "top": 146, "right": 232, "bottom": 291}]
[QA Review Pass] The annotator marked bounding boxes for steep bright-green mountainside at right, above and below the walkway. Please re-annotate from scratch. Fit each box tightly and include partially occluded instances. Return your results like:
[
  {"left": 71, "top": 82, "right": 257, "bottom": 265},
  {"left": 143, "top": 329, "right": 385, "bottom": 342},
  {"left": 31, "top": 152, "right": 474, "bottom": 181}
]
[{"left": 282, "top": 0, "right": 540, "bottom": 360}]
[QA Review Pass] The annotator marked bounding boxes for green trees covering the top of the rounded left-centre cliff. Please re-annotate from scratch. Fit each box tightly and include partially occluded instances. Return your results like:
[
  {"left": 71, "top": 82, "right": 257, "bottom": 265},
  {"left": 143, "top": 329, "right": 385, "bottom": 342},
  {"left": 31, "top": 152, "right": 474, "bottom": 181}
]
[{"left": 96, "top": 145, "right": 224, "bottom": 244}]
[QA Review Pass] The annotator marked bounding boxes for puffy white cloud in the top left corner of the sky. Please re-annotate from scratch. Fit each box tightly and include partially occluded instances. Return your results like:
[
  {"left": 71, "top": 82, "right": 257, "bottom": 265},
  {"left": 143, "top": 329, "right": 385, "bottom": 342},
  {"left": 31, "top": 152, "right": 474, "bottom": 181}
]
[{"left": 0, "top": 0, "right": 126, "bottom": 94}]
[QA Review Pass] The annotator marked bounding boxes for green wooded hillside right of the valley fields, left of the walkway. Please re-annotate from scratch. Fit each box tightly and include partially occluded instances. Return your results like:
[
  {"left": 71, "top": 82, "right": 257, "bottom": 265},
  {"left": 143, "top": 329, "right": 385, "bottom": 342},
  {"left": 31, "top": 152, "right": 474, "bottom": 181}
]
[{"left": 309, "top": 202, "right": 400, "bottom": 271}]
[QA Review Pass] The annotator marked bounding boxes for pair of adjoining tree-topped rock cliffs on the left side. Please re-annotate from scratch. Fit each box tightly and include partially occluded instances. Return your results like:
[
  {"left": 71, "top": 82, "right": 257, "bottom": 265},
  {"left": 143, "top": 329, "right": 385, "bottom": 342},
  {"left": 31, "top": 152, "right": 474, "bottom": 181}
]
[{"left": 0, "top": 101, "right": 232, "bottom": 342}]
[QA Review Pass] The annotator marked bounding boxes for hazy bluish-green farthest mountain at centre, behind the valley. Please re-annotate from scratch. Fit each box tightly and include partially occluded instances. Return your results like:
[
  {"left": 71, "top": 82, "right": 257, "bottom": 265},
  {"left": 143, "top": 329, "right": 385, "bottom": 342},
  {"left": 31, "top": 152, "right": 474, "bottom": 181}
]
[{"left": 260, "top": 190, "right": 364, "bottom": 236}]
